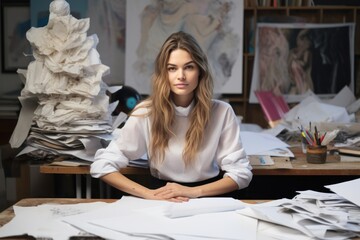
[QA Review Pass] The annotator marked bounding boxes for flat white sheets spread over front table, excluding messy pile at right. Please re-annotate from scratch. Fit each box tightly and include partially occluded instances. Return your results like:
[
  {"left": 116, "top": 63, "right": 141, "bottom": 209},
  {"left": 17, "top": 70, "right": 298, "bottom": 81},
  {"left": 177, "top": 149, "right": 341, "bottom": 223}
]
[{"left": 0, "top": 196, "right": 257, "bottom": 240}]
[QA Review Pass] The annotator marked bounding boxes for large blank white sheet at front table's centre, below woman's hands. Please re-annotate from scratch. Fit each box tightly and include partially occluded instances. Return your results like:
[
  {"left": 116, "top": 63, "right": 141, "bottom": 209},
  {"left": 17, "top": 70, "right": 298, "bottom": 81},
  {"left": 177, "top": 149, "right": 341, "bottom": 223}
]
[{"left": 90, "top": 211, "right": 256, "bottom": 239}]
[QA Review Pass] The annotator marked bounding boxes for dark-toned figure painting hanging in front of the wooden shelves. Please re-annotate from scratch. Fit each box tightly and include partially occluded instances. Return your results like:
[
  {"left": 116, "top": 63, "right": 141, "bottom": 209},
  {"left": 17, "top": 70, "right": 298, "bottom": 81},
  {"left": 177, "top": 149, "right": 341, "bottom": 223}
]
[{"left": 250, "top": 23, "right": 355, "bottom": 103}]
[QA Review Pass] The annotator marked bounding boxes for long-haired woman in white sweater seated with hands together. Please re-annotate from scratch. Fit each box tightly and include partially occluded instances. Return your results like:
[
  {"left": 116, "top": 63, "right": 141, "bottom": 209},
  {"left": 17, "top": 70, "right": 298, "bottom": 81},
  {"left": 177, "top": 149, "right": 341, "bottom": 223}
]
[{"left": 91, "top": 32, "right": 252, "bottom": 202}]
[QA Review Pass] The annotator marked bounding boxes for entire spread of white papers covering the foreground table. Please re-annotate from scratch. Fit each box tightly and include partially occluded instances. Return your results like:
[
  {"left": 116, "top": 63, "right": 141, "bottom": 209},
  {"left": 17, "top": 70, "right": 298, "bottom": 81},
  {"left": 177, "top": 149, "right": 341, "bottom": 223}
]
[{"left": 0, "top": 179, "right": 360, "bottom": 240}]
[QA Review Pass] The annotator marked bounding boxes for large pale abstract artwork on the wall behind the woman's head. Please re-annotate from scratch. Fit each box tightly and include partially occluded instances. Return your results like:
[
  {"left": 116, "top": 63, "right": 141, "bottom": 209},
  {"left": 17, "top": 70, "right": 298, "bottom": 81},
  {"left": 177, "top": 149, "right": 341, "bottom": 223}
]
[{"left": 125, "top": 0, "right": 243, "bottom": 94}]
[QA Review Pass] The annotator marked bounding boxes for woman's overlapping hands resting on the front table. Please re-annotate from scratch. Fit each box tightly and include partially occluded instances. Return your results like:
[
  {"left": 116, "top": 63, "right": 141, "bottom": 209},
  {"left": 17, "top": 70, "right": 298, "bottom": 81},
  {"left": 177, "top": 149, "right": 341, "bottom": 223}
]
[{"left": 153, "top": 183, "right": 200, "bottom": 202}]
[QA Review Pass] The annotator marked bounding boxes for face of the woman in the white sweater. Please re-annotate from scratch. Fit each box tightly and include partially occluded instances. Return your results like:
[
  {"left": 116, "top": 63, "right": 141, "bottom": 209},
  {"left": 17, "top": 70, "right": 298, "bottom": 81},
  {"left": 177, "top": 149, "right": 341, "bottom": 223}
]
[{"left": 167, "top": 49, "right": 200, "bottom": 107}]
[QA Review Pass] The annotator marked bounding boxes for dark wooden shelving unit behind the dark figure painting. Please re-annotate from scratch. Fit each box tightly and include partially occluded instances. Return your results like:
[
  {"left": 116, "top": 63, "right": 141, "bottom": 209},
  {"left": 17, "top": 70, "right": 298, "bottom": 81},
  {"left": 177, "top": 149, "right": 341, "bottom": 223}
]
[{"left": 223, "top": 5, "right": 360, "bottom": 127}]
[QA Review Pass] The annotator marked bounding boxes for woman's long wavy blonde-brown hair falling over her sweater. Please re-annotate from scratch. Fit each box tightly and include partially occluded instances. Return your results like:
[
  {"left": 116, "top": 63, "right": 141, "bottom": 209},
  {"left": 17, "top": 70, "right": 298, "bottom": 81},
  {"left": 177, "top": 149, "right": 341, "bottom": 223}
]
[{"left": 136, "top": 31, "right": 213, "bottom": 166}]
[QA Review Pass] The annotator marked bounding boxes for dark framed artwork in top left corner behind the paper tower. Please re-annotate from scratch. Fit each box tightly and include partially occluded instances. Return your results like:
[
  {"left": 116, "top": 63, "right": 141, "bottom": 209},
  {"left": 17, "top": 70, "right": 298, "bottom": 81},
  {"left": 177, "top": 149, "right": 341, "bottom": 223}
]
[{"left": 0, "top": 0, "right": 32, "bottom": 73}]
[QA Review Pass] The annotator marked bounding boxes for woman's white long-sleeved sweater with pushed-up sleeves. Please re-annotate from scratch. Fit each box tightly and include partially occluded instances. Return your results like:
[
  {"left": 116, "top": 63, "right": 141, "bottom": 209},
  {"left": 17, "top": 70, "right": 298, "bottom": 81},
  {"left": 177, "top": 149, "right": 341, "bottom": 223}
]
[{"left": 90, "top": 100, "right": 252, "bottom": 189}]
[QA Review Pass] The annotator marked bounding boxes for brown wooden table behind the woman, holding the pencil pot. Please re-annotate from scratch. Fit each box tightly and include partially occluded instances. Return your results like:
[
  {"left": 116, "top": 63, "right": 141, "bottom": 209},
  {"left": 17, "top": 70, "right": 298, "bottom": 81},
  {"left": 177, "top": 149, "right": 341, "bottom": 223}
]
[{"left": 40, "top": 147, "right": 360, "bottom": 198}]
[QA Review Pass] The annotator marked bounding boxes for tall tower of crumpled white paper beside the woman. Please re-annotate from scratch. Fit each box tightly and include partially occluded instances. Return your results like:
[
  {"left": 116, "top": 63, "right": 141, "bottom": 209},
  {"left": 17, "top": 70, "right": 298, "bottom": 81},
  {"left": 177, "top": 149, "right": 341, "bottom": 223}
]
[{"left": 10, "top": 0, "right": 116, "bottom": 160}]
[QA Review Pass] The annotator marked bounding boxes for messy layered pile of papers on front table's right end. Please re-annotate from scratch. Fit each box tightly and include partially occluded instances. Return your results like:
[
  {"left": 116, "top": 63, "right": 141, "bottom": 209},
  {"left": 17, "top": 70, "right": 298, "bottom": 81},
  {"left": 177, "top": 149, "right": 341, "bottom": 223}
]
[{"left": 237, "top": 179, "right": 360, "bottom": 239}]
